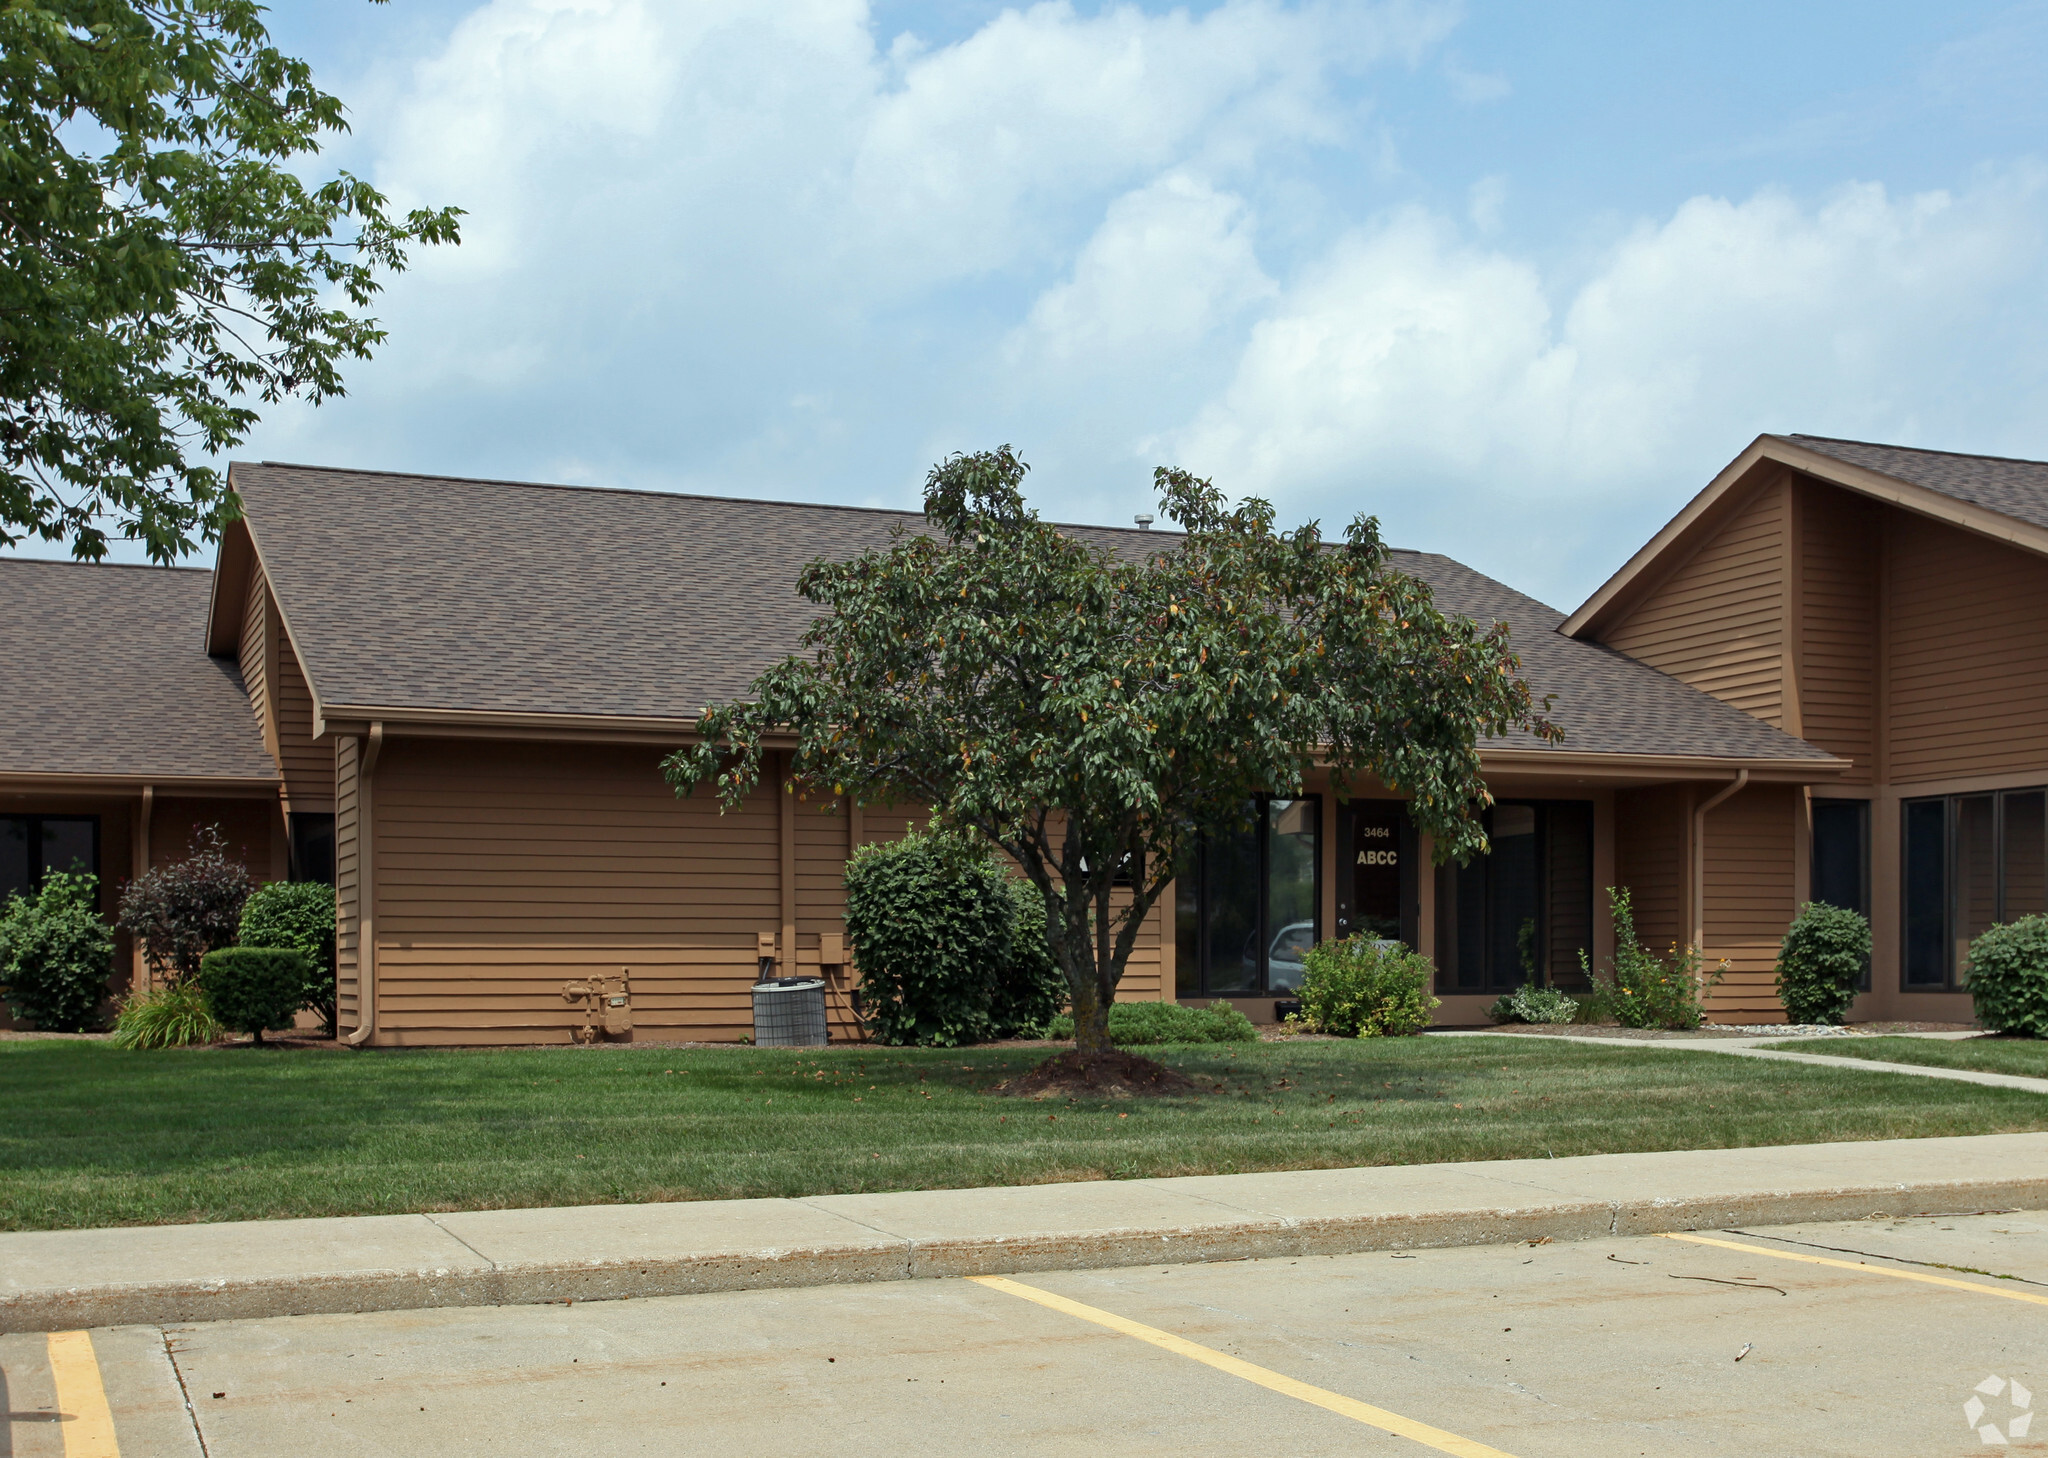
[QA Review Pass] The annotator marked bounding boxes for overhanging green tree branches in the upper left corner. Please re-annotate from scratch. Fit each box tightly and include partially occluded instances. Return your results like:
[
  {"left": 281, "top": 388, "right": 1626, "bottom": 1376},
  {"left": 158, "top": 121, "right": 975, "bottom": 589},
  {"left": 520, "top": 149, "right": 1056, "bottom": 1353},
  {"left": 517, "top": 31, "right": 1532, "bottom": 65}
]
[{"left": 0, "top": 0, "right": 459, "bottom": 563}]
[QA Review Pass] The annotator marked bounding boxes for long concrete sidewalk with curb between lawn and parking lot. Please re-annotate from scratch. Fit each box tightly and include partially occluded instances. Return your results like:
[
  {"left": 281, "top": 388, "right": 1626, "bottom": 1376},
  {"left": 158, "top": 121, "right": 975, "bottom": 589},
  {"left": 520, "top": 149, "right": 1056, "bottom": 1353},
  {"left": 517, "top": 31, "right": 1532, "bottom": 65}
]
[{"left": 0, "top": 1132, "right": 2048, "bottom": 1331}]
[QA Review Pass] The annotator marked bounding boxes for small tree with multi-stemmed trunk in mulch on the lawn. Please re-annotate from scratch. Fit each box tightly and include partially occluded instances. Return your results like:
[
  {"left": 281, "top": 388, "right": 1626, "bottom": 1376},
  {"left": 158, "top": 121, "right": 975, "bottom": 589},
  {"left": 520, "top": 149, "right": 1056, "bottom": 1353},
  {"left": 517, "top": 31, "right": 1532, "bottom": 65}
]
[{"left": 664, "top": 446, "right": 1556, "bottom": 1053}]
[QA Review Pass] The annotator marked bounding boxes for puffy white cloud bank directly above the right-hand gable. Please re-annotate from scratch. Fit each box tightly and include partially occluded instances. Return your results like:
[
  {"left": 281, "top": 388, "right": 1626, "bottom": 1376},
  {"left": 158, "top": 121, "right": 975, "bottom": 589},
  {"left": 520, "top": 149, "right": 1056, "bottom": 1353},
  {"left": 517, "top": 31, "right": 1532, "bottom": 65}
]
[{"left": 1145, "top": 159, "right": 2048, "bottom": 590}]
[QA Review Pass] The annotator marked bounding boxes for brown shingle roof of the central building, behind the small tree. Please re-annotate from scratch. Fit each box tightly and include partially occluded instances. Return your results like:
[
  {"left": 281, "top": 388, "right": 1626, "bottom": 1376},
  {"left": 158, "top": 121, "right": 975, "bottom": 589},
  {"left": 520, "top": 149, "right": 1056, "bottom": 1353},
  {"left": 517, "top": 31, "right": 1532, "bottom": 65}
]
[{"left": 233, "top": 463, "right": 1827, "bottom": 760}]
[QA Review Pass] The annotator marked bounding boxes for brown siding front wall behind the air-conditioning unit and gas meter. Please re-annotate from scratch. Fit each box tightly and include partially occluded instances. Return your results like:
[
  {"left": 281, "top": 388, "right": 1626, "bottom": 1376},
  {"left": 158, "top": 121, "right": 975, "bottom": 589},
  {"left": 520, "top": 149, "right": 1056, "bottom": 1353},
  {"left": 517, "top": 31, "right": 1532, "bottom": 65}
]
[{"left": 336, "top": 739, "right": 1159, "bottom": 1044}]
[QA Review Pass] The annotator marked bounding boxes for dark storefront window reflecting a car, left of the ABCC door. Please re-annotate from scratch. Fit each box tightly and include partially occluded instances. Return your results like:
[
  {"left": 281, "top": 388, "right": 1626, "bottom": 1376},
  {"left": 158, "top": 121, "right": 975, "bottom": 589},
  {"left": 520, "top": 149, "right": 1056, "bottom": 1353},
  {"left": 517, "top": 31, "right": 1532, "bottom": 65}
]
[{"left": 1174, "top": 795, "right": 1323, "bottom": 997}]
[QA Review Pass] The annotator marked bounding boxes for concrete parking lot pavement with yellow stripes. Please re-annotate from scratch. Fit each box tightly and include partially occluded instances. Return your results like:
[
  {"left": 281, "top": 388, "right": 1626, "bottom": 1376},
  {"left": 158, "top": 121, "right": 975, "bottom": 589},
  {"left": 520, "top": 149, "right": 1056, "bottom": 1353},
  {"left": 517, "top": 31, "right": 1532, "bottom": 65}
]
[{"left": 19, "top": 1212, "right": 2048, "bottom": 1458}]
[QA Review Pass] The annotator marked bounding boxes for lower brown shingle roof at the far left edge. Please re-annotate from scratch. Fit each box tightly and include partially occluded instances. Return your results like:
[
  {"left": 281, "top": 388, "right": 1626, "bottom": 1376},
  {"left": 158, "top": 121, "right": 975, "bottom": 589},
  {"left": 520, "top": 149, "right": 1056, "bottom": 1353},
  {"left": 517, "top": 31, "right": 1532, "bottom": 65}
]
[{"left": 0, "top": 557, "right": 276, "bottom": 780}]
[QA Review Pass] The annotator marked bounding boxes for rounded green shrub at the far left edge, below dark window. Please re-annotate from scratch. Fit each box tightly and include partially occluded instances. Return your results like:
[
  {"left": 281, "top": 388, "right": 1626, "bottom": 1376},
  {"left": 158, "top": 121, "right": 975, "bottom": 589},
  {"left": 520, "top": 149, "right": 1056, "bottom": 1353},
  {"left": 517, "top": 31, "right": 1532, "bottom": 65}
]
[{"left": 0, "top": 870, "right": 115, "bottom": 1032}]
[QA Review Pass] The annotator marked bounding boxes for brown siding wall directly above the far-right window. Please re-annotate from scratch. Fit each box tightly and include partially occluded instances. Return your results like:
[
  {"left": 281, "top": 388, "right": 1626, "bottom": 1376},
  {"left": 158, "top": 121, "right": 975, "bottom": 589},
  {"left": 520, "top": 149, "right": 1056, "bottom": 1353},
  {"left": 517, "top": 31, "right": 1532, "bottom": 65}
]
[{"left": 1886, "top": 518, "right": 2048, "bottom": 784}]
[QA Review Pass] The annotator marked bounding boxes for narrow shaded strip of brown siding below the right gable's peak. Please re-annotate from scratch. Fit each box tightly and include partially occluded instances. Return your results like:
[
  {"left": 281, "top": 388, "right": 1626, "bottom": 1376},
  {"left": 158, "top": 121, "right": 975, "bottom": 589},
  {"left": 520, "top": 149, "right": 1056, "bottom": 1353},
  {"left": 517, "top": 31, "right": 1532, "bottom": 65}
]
[{"left": 1798, "top": 479, "right": 1884, "bottom": 784}]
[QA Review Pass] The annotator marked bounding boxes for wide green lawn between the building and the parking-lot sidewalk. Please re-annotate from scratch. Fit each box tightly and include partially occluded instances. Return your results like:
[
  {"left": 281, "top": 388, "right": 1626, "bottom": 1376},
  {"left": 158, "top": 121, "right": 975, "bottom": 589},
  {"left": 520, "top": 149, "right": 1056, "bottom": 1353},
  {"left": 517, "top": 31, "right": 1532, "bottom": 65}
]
[{"left": 0, "top": 1036, "right": 2048, "bottom": 1231}]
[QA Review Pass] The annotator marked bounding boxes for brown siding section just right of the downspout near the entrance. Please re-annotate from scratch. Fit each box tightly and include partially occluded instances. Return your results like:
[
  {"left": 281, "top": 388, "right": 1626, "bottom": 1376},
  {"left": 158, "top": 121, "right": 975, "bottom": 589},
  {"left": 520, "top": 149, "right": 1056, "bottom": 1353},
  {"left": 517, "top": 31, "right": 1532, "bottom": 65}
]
[{"left": 1695, "top": 784, "right": 1800, "bottom": 1022}]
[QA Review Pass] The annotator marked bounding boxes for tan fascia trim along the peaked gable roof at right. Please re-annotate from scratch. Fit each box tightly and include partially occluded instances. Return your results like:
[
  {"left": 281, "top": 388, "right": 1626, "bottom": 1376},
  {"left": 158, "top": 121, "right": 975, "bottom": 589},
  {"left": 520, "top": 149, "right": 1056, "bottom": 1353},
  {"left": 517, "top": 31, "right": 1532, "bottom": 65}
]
[{"left": 1559, "top": 434, "right": 2048, "bottom": 639}]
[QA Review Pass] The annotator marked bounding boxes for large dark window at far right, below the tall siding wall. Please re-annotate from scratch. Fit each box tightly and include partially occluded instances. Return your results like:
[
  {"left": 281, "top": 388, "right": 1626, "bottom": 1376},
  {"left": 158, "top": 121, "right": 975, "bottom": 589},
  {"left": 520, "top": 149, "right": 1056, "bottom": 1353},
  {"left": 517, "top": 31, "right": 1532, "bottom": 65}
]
[{"left": 1901, "top": 790, "right": 2048, "bottom": 991}]
